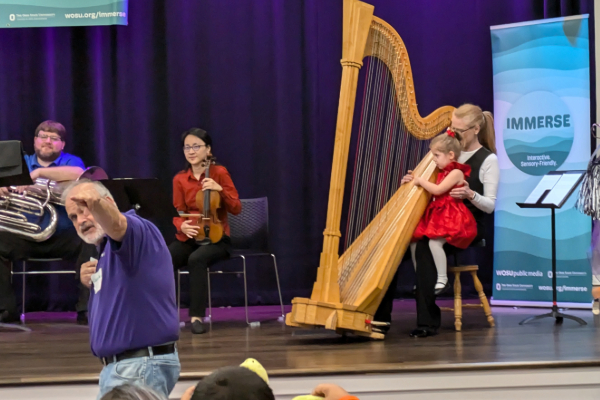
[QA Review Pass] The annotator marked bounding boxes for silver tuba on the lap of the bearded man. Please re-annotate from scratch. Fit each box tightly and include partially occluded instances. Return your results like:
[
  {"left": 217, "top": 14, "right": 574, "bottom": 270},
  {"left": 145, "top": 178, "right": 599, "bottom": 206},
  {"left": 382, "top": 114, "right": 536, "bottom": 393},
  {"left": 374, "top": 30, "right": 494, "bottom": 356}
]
[{"left": 0, "top": 167, "right": 108, "bottom": 242}]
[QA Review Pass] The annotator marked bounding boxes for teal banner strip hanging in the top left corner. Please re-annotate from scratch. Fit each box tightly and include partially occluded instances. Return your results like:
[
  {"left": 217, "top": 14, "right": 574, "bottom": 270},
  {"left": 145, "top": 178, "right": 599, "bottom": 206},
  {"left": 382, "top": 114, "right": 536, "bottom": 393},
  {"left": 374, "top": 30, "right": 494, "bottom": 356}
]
[{"left": 0, "top": 0, "right": 129, "bottom": 28}]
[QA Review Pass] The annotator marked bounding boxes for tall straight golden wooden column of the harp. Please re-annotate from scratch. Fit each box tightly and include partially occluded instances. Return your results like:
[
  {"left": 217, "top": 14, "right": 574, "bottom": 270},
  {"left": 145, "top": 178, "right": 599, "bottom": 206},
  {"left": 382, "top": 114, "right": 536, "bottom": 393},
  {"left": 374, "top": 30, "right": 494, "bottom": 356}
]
[{"left": 311, "top": 0, "right": 374, "bottom": 303}]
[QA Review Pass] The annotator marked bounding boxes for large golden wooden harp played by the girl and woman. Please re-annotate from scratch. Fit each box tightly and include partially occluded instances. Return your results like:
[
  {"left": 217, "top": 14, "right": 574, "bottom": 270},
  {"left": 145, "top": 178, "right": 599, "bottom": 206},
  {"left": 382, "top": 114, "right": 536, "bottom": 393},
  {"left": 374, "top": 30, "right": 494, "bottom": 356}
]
[{"left": 286, "top": 0, "right": 454, "bottom": 338}]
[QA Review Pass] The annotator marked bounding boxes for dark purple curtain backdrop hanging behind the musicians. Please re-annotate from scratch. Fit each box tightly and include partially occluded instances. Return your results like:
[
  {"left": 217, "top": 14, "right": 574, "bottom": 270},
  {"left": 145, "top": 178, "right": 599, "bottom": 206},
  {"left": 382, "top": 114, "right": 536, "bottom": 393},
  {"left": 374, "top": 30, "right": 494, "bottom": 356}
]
[{"left": 0, "top": 0, "right": 593, "bottom": 310}]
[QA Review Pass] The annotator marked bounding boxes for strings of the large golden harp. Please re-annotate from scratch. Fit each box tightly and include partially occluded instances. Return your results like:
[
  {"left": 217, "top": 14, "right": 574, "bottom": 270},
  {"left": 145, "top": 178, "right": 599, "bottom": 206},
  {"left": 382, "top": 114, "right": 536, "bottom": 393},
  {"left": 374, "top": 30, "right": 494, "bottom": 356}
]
[{"left": 339, "top": 29, "right": 429, "bottom": 297}]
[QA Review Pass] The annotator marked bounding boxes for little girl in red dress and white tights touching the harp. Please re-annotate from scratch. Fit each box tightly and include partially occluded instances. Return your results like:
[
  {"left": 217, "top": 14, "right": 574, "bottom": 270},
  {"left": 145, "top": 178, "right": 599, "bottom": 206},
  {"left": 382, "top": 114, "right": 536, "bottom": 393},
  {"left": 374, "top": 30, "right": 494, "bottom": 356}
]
[{"left": 411, "top": 129, "right": 477, "bottom": 294}]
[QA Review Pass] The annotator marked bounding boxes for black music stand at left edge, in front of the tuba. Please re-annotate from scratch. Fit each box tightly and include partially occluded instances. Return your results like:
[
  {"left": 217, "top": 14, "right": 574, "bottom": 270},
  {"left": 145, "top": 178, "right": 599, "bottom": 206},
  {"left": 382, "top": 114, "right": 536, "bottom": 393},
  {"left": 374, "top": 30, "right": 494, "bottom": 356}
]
[{"left": 0, "top": 140, "right": 33, "bottom": 332}]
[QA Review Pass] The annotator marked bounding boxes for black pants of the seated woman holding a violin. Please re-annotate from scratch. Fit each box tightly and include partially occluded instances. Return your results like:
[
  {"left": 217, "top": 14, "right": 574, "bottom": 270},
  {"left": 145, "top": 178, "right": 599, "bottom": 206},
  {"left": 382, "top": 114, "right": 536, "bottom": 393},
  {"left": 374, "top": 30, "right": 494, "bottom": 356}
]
[{"left": 169, "top": 236, "right": 231, "bottom": 317}]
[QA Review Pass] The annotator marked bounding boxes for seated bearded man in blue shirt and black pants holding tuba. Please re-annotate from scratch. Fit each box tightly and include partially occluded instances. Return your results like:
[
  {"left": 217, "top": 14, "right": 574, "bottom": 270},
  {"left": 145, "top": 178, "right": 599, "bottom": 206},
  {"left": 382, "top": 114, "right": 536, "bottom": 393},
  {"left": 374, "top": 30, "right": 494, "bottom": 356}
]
[{"left": 0, "top": 121, "right": 89, "bottom": 324}]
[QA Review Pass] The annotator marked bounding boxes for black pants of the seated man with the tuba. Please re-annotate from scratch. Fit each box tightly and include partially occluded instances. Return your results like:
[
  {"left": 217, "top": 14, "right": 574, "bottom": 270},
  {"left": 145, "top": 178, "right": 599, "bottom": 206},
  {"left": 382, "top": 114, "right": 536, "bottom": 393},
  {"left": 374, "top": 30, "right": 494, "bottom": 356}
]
[{"left": 0, "top": 228, "right": 89, "bottom": 313}]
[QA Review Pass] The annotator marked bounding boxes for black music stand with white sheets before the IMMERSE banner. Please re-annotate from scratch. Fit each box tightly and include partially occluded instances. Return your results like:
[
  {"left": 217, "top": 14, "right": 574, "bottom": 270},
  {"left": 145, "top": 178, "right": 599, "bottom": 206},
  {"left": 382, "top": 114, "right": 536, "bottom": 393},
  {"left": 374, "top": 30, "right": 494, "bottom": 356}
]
[{"left": 517, "top": 171, "right": 587, "bottom": 325}]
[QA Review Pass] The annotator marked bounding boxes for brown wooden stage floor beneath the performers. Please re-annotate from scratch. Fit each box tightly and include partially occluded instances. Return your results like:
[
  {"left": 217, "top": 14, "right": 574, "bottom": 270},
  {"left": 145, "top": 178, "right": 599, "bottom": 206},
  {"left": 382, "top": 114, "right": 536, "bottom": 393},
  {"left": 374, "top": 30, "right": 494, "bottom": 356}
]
[{"left": 0, "top": 300, "right": 600, "bottom": 385}]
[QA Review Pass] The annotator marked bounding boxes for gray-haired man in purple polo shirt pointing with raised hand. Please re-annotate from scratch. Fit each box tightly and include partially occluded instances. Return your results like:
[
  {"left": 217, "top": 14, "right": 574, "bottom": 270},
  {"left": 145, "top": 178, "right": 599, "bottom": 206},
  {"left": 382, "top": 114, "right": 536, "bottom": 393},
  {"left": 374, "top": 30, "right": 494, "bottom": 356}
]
[{"left": 63, "top": 180, "right": 181, "bottom": 398}]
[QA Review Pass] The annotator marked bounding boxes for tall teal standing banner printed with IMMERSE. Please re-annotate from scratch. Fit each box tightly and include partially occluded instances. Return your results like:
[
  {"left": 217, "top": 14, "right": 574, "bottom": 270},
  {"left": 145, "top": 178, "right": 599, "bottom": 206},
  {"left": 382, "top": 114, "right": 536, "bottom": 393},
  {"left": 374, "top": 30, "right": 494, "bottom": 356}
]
[{"left": 491, "top": 15, "right": 592, "bottom": 305}]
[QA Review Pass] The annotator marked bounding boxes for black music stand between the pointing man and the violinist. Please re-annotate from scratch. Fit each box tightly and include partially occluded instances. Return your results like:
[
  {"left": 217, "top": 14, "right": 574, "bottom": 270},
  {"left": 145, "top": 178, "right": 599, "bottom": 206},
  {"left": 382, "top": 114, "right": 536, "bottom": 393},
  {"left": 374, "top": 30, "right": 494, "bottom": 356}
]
[{"left": 101, "top": 178, "right": 179, "bottom": 223}]
